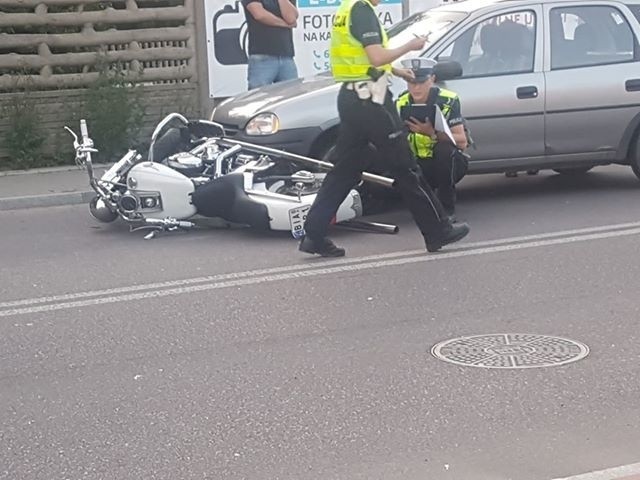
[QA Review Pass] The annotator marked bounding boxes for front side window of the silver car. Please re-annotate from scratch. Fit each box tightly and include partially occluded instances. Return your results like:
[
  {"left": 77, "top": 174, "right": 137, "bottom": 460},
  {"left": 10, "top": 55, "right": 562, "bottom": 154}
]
[{"left": 437, "top": 10, "right": 537, "bottom": 78}]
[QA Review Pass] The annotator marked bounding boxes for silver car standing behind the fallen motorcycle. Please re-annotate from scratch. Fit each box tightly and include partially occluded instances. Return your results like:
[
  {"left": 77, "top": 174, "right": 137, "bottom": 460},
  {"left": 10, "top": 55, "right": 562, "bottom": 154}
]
[{"left": 211, "top": 0, "right": 640, "bottom": 178}]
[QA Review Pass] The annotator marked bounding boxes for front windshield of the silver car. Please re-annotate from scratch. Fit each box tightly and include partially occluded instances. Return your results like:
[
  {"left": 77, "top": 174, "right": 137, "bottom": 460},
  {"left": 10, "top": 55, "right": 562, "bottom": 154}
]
[{"left": 387, "top": 10, "right": 467, "bottom": 48}]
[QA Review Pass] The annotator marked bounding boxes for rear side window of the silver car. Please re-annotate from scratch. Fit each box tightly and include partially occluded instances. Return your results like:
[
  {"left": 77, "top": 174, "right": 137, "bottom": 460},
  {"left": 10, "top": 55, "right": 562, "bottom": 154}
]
[{"left": 549, "top": 5, "right": 636, "bottom": 69}]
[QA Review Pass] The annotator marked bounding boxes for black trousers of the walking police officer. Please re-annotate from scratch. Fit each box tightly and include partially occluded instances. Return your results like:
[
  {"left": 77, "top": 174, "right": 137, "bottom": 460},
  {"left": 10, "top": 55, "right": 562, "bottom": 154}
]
[{"left": 305, "top": 85, "right": 448, "bottom": 241}]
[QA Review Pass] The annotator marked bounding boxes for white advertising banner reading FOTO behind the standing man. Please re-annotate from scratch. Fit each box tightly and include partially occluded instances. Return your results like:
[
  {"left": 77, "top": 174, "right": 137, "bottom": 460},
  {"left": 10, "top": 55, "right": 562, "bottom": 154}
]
[{"left": 204, "top": 0, "right": 403, "bottom": 98}]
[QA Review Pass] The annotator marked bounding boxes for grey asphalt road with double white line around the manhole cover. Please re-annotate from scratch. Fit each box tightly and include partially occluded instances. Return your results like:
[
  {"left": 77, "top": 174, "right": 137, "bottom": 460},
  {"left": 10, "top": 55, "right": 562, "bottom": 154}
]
[{"left": 0, "top": 167, "right": 640, "bottom": 480}]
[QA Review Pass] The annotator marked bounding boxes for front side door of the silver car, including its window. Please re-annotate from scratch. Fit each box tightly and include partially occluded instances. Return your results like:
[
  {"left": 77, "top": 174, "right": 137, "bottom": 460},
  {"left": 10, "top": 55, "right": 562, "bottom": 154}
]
[{"left": 427, "top": 4, "right": 545, "bottom": 171}]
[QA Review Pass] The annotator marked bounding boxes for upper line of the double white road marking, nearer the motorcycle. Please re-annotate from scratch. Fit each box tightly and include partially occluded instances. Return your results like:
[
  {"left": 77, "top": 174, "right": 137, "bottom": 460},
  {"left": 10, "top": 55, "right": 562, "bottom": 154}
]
[{"left": 0, "top": 222, "right": 640, "bottom": 309}]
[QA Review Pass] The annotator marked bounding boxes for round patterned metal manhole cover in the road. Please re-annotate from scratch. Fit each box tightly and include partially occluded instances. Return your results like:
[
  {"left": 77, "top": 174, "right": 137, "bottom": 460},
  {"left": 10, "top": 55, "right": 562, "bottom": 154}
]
[{"left": 431, "top": 333, "right": 589, "bottom": 368}]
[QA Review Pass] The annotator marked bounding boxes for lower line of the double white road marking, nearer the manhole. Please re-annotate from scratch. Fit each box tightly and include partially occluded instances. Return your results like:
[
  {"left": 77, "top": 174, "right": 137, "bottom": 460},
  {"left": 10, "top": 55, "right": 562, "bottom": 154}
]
[{"left": 0, "top": 225, "right": 640, "bottom": 317}]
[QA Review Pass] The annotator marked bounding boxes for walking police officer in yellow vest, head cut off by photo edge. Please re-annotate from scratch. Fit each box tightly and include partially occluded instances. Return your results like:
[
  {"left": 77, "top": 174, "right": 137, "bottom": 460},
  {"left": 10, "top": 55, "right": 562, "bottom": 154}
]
[{"left": 299, "top": 0, "right": 469, "bottom": 257}]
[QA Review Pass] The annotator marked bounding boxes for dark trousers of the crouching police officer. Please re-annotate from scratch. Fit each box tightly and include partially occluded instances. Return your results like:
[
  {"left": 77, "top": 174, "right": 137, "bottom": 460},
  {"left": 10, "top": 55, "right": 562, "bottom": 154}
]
[{"left": 418, "top": 142, "right": 459, "bottom": 215}]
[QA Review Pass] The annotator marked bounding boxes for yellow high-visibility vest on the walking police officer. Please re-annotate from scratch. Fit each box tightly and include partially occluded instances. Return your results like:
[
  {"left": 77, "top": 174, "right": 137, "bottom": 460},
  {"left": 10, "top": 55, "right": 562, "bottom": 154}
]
[{"left": 329, "top": 0, "right": 391, "bottom": 82}]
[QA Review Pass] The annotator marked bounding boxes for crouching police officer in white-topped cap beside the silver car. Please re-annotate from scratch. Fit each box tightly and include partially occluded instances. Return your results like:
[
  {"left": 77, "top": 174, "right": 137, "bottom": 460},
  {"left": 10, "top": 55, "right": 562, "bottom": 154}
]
[{"left": 396, "top": 58, "right": 468, "bottom": 219}]
